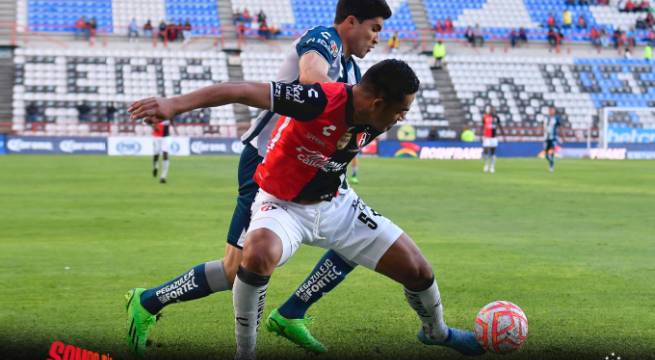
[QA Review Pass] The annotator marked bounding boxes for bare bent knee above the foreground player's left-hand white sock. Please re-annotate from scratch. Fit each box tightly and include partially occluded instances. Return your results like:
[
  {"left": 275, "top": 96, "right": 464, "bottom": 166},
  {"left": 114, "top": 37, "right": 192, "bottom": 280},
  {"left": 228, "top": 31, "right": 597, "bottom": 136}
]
[{"left": 241, "top": 229, "right": 282, "bottom": 275}]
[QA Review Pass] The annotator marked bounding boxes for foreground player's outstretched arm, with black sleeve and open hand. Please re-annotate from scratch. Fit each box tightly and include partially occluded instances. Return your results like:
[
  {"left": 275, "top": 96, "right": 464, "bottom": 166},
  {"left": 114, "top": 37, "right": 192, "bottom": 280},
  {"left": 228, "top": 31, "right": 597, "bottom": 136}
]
[{"left": 128, "top": 82, "right": 327, "bottom": 124}]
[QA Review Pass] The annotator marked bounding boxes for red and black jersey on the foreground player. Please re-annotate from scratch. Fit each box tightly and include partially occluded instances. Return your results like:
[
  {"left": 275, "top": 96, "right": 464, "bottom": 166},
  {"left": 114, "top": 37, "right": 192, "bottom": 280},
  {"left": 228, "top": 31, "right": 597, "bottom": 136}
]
[{"left": 254, "top": 82, "right": 381, "bottom": 201}]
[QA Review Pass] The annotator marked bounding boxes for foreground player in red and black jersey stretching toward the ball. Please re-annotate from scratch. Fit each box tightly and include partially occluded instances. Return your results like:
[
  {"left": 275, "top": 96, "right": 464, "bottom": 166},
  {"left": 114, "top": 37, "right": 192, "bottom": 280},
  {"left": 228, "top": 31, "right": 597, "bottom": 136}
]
[{"left": 129, "top": 59, "right": 484, "bottom": 359}]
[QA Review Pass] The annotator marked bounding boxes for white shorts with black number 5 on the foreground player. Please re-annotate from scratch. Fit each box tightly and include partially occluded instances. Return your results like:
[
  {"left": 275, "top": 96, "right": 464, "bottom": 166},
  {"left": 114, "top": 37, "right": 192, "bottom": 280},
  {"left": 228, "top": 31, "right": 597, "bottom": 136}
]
[{"left": 239, "top": 189, "right": 403, "bottom": 270}]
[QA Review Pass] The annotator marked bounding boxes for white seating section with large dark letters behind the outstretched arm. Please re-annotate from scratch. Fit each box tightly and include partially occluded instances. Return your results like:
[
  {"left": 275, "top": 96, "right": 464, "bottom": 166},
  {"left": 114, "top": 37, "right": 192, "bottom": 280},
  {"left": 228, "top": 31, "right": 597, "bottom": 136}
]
[{"left": 13, "top": 49, "right": 236, "bottom": 136}]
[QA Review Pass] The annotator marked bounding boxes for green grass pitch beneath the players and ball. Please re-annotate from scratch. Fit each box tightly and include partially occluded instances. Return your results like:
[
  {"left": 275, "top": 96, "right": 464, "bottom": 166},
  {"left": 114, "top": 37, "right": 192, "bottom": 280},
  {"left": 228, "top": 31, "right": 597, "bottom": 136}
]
[{"left": 0, "top": 156, "right": 655, "bottom": 359}]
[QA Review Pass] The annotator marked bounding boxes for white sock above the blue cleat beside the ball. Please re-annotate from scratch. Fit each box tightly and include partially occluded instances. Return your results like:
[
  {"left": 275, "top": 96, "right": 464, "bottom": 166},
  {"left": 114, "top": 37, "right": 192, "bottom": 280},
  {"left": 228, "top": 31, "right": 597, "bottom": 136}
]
[{"left": 405, "top": 280, "right": 448, "bottom": 341}]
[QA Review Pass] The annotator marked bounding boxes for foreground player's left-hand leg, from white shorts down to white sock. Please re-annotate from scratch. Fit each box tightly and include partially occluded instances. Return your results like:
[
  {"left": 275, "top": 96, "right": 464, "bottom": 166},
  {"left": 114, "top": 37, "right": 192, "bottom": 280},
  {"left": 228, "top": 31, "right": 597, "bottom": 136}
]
[{"left": 232, "top": 193, "right": 304, "bottom": 359}]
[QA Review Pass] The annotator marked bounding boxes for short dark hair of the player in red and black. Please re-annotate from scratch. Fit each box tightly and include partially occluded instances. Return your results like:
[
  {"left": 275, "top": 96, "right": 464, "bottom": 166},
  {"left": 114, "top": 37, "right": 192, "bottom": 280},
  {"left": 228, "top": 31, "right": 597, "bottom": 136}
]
[{"left": 360, "top": 59, "right": 421, "bottom": 103}]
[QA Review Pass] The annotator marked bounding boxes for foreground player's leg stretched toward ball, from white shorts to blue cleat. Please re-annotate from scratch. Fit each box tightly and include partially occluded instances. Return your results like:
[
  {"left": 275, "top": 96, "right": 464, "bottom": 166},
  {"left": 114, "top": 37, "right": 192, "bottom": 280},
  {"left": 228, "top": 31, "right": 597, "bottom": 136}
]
[{"left": 330, "top": 191, "right": 483, "bottom": 354}]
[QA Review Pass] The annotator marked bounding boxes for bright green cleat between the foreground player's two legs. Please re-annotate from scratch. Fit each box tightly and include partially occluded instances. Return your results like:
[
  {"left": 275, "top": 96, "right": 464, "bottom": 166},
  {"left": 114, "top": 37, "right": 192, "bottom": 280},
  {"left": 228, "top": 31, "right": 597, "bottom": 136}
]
[{"left": 266, "top": 309, "right": 327, "bottom": 354}]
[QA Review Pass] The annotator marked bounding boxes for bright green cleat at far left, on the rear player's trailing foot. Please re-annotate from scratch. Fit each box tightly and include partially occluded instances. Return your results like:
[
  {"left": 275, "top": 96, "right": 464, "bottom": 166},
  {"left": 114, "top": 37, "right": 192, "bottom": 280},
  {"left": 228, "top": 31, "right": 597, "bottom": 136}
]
[{"left": 125, "top": 288, "right": 157, "bottom": 355}]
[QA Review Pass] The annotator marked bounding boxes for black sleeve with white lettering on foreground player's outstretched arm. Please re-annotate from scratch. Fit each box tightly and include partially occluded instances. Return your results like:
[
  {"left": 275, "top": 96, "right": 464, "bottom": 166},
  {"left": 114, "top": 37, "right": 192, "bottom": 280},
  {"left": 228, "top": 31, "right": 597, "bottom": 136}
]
[{"left": 271, "top": 81, "right": 328, "bottom": 121}]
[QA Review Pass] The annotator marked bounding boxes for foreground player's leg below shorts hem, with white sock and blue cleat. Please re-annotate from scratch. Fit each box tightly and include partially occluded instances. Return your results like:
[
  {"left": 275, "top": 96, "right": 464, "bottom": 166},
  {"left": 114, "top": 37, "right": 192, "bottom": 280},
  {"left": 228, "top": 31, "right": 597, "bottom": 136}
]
[{"left": 375, "top": 234, "right": 485, "bottom": 355}]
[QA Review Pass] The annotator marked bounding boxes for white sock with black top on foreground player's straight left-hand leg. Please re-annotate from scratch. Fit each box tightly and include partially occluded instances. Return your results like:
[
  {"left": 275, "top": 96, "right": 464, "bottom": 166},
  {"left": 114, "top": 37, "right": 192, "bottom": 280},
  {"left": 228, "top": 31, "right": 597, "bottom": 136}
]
[{"left": 232, "top": 267, "right": 269, "bottom": 360}]
